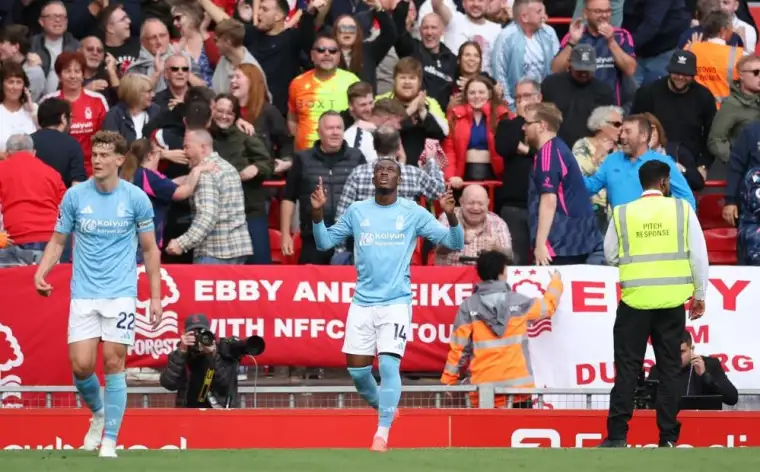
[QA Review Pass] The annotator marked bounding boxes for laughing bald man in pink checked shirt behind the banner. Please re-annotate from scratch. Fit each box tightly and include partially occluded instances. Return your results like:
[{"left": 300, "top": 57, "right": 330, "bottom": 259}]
[{"left": 435, "top": 185, "right": 512, "bottom": 266}]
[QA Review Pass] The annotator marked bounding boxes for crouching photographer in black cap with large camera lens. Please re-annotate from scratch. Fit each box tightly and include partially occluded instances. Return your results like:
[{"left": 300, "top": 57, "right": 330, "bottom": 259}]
[{"left": 160, "top": 314, "right": 264, "bottom": 408}]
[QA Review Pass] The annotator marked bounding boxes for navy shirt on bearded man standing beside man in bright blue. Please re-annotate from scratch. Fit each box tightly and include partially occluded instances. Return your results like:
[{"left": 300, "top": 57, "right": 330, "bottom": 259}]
[{"left": 528, "top": 137, "right": 602, "bottom": 256}]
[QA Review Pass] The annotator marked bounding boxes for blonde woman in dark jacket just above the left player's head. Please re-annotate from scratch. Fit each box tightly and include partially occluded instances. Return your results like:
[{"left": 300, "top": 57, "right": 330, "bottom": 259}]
[{"left": 103, "top": 74, "right": 160, "bottom": 144}]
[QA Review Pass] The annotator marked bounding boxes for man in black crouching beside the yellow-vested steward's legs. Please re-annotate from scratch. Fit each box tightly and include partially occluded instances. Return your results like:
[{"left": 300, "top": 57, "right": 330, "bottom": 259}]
[{"left": 648, "top": 331, "right": 739, "bottom": 405}]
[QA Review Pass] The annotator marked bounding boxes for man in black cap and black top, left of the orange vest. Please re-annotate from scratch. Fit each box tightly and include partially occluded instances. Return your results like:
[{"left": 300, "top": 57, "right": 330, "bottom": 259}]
[{"left": 631, "top": 51, "right": 716, "bottom": 178}]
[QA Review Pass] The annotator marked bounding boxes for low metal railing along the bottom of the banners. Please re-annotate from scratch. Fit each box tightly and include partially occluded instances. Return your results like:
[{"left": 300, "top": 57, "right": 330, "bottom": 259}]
[{"left": 0, "top": 385, "right": 760, "bottom": 411}]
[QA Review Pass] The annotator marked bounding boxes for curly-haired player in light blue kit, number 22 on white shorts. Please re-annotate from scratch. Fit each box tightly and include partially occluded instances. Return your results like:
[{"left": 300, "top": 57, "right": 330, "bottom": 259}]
[{"left": 34, "top": 131, "right": 162, "bottom": 457}]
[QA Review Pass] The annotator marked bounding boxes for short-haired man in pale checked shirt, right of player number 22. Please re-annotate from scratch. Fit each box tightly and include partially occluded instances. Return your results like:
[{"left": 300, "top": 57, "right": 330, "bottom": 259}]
[{"left": 166, "top": 129, "right": 253, "bottom": 264}]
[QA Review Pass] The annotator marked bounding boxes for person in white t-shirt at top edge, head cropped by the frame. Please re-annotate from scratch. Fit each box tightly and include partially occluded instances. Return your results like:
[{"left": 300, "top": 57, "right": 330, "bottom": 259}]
[{"left": 431, "top": 0, "right": 508, "bottom": 74}]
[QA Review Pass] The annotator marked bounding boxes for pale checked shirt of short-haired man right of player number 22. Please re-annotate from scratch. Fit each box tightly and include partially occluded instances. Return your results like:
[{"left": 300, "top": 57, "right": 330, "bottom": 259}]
[{"left": 177, "top": 153, "right": 253, "bottom": 259}]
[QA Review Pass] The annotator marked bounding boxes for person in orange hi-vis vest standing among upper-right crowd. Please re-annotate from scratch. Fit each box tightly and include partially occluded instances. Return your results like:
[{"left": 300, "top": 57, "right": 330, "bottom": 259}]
[{"left": 687, "top": 11, "right": 744, "bottom": 108}]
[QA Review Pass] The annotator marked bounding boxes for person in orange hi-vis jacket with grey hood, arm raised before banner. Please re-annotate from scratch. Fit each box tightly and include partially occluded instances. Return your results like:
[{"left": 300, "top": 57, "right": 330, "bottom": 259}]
[{"left": 441, "top": 251, "right": 563, "bottom": 408}]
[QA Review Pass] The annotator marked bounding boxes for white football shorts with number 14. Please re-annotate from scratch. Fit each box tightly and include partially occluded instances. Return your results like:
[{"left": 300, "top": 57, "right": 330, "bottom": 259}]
[{"left": 343, "top": 303, "right": 412, "bottom": 356}]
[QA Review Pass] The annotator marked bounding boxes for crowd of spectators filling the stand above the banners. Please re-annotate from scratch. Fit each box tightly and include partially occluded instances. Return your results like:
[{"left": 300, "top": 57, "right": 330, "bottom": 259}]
[{"left": 0, "top": 0, "right": 760, "bottom": 276}]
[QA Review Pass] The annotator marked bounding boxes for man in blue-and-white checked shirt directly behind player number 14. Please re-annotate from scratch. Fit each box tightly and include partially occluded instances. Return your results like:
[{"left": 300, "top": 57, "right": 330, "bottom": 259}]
[{"left": 332, "top": 124, "right": 446, "bottom": 265}]
